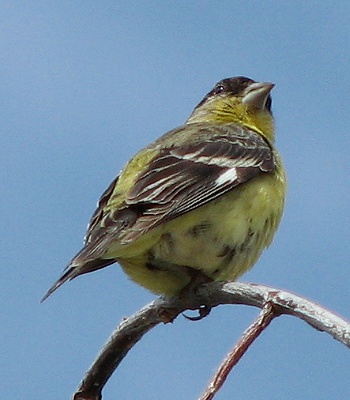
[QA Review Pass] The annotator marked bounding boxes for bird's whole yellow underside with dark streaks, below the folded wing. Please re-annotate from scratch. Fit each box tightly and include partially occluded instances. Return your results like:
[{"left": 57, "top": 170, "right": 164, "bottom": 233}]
[{"left": 120, "top": 175, "right": 284, "bottom": 294}]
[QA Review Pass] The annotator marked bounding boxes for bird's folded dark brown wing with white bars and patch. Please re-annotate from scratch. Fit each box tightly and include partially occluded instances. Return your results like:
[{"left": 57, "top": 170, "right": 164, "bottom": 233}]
[{"left": 87, "top": 125, "right": 275, "bottom": 245}]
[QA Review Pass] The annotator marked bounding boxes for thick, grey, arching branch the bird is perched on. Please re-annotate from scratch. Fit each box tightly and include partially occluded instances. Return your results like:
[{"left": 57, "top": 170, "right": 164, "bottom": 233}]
[{"left": 73, "top": 282, "right": 350, "bottom": 400}]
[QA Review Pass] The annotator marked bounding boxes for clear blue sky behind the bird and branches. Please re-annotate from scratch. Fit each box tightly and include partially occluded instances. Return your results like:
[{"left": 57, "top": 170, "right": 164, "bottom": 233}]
[{"left": 0, "top": 0, "right": 350, "bottom": 400}]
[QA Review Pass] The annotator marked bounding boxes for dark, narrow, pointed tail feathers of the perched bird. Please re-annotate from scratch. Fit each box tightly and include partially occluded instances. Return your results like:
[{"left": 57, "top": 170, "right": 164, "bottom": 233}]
[{"left": 41, "top": 258, "right": 116, "bottom": 303}]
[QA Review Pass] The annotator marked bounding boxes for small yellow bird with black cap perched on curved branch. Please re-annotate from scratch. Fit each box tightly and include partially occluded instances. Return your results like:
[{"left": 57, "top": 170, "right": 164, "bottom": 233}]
[{"left": 43, "top": 77, "right": 286, "bottom": 300}]
